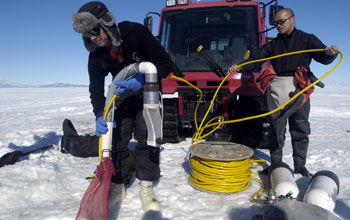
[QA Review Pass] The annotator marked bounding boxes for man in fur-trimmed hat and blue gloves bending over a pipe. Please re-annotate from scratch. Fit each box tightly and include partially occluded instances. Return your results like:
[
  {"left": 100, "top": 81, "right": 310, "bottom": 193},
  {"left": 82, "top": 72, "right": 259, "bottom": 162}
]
[{"left": 73, "top": 1, "right": 172, "bottom": 212}]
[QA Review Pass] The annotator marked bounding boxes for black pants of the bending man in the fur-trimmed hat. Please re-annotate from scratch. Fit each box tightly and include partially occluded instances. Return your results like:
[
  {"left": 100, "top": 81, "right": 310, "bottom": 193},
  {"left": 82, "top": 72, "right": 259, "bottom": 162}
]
[{"left": 112, "top": 96, "right": 160, "bottom": 183}]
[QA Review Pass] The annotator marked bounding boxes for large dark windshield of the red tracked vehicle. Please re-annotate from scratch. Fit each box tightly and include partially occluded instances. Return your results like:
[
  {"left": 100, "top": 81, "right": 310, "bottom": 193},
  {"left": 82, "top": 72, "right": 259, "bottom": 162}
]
[{"left": 159, "top": 6, "right": 259, "bottom": 72}]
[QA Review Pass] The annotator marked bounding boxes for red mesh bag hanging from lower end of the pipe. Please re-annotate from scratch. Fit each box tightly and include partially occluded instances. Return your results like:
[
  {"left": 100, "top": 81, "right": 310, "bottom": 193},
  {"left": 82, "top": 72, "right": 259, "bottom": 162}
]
[{"left": 75, "top": 157, "right": 114, "bottom": 220}]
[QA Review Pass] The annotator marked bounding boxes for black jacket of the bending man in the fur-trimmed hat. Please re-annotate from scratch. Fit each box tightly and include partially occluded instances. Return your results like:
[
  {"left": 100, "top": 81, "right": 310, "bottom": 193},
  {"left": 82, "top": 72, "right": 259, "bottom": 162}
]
[{"left": 88, "top": 21, "right": 173, "bottom": 118}]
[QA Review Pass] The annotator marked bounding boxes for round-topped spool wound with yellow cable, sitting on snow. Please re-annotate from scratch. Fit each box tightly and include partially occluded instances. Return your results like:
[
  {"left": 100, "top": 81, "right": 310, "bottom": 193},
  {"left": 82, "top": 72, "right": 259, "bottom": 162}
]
[{"left": 189, "top": 141, "right": 266, "bottom": 200}]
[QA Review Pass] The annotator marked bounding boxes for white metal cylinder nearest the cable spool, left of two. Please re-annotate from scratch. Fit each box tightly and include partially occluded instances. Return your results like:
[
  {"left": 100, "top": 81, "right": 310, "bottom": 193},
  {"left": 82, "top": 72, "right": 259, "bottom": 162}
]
[{"left": 269, "top": 162, "right": 299, "bottom": 199}]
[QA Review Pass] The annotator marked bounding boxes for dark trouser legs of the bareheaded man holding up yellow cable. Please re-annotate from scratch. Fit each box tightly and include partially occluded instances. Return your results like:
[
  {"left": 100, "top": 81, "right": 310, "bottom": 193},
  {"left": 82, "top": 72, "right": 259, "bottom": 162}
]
[{"left": 268, "top": 99, "right": 311, "bottom": 170}]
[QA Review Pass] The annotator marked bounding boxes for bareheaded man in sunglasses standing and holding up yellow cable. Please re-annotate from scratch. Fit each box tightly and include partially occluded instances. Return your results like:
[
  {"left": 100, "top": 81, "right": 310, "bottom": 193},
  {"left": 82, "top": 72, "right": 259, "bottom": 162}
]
[{"left": 229, "top": 8, "right": 337, "bottom": 177}]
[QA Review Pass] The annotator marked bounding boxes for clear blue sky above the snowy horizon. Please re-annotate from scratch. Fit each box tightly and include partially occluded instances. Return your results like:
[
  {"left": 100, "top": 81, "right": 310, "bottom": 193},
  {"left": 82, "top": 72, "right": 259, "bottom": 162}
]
[{"left": 0, "top": 0, "right": 350, "bottom": 85}]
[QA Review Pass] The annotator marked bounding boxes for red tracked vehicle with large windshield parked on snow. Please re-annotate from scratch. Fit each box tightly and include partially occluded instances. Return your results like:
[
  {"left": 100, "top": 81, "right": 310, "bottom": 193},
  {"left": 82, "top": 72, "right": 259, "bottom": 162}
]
[{"left": 145, "top": 0, "right": 281, "bottom": 148}]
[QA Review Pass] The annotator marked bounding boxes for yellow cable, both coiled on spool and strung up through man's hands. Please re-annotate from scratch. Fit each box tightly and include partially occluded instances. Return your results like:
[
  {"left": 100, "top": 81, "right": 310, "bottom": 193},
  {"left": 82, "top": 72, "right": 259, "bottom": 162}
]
[{"left": 171, "top": 49, "right": 344, "bottom": 201}]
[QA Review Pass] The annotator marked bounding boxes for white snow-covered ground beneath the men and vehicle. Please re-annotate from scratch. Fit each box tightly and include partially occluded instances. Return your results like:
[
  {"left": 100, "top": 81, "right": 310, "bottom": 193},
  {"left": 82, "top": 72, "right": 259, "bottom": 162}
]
[{"left": 0, "top": 85, "right": 350, "bottom": 220}]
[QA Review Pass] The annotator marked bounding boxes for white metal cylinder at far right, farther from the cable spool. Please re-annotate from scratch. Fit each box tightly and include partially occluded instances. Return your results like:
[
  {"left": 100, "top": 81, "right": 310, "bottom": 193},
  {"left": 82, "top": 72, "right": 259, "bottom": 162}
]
[{"left": 303, "top": 170, "right": 339, "bottom": 212}]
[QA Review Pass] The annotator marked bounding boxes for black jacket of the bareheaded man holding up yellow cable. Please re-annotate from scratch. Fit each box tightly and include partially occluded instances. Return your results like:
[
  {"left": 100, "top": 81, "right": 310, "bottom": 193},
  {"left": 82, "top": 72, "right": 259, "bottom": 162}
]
[{"left": 241, "top": 29, "right": 336, "bottom": 76}]
